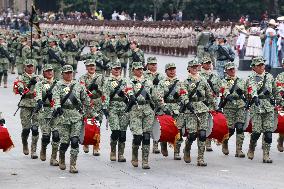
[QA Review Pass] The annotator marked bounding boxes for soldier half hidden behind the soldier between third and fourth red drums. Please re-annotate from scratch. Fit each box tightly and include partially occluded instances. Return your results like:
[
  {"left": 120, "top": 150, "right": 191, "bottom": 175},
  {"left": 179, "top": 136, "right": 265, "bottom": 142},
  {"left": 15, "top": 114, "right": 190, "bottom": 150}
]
[{"left": 200, "top": 56, "right": 222, "bottom": 152}]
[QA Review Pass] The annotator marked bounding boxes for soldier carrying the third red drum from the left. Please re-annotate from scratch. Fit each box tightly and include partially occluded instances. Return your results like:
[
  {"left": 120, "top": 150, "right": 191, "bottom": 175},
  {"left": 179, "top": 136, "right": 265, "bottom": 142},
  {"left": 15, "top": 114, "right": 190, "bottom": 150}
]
[{"left": 157, "top": 63, "right": 183, "bottom": 160}]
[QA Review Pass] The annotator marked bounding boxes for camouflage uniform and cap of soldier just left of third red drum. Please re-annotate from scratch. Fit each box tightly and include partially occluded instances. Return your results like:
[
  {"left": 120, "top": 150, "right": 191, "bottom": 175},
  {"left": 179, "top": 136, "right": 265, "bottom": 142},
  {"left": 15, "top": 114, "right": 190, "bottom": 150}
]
[{"left": 129, "top": 62, "right": 155, "bottom": 169}]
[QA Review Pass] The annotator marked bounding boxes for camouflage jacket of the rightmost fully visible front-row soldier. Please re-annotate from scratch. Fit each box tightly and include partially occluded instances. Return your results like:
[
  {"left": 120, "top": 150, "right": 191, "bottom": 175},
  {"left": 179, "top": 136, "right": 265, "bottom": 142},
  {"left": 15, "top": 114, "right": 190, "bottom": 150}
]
[{"left": 246, "top": 71, "right": 275, "bottom": 113}]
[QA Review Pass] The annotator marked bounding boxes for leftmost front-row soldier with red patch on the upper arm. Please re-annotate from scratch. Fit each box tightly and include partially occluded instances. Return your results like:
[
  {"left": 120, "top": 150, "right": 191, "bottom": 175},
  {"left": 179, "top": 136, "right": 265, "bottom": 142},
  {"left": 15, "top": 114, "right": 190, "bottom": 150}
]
[{"left": 14, "top": 59, "right": 41, "bottom": 159}]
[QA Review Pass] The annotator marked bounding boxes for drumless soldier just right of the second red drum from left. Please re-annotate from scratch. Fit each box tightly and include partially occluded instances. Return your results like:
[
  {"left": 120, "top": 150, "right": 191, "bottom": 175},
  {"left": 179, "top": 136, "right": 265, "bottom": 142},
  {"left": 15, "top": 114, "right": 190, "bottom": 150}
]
[{"left": 103, "top": 62, "right": 129, "bottom": 162}]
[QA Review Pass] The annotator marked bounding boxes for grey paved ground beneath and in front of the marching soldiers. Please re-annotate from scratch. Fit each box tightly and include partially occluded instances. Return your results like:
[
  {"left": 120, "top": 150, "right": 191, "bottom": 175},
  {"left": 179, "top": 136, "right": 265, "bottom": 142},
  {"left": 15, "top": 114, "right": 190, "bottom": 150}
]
[{"left": 0, "top": 53, "right": 284, "bottom": 189}]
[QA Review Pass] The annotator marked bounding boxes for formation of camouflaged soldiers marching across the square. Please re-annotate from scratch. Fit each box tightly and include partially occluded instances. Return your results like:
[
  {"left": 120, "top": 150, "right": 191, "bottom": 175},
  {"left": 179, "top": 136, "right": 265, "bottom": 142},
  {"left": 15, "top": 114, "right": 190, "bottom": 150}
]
[{"left": 0, "top": 21, "right": 284, "bottom": 173}]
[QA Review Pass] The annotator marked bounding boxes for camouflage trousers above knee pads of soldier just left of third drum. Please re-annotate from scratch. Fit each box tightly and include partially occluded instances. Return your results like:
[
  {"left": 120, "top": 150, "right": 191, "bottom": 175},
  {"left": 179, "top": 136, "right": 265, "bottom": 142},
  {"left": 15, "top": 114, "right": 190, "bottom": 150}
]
[{"left": 129, "top": 104, "right": 155, "bottom": 135}]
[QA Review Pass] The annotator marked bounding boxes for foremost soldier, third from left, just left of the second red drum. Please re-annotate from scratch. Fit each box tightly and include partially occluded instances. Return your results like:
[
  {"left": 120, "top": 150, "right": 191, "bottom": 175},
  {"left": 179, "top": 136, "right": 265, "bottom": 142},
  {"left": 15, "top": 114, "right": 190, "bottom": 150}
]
[{"left": 52, "top": 65, "right": 93, "bottom": 173}]
